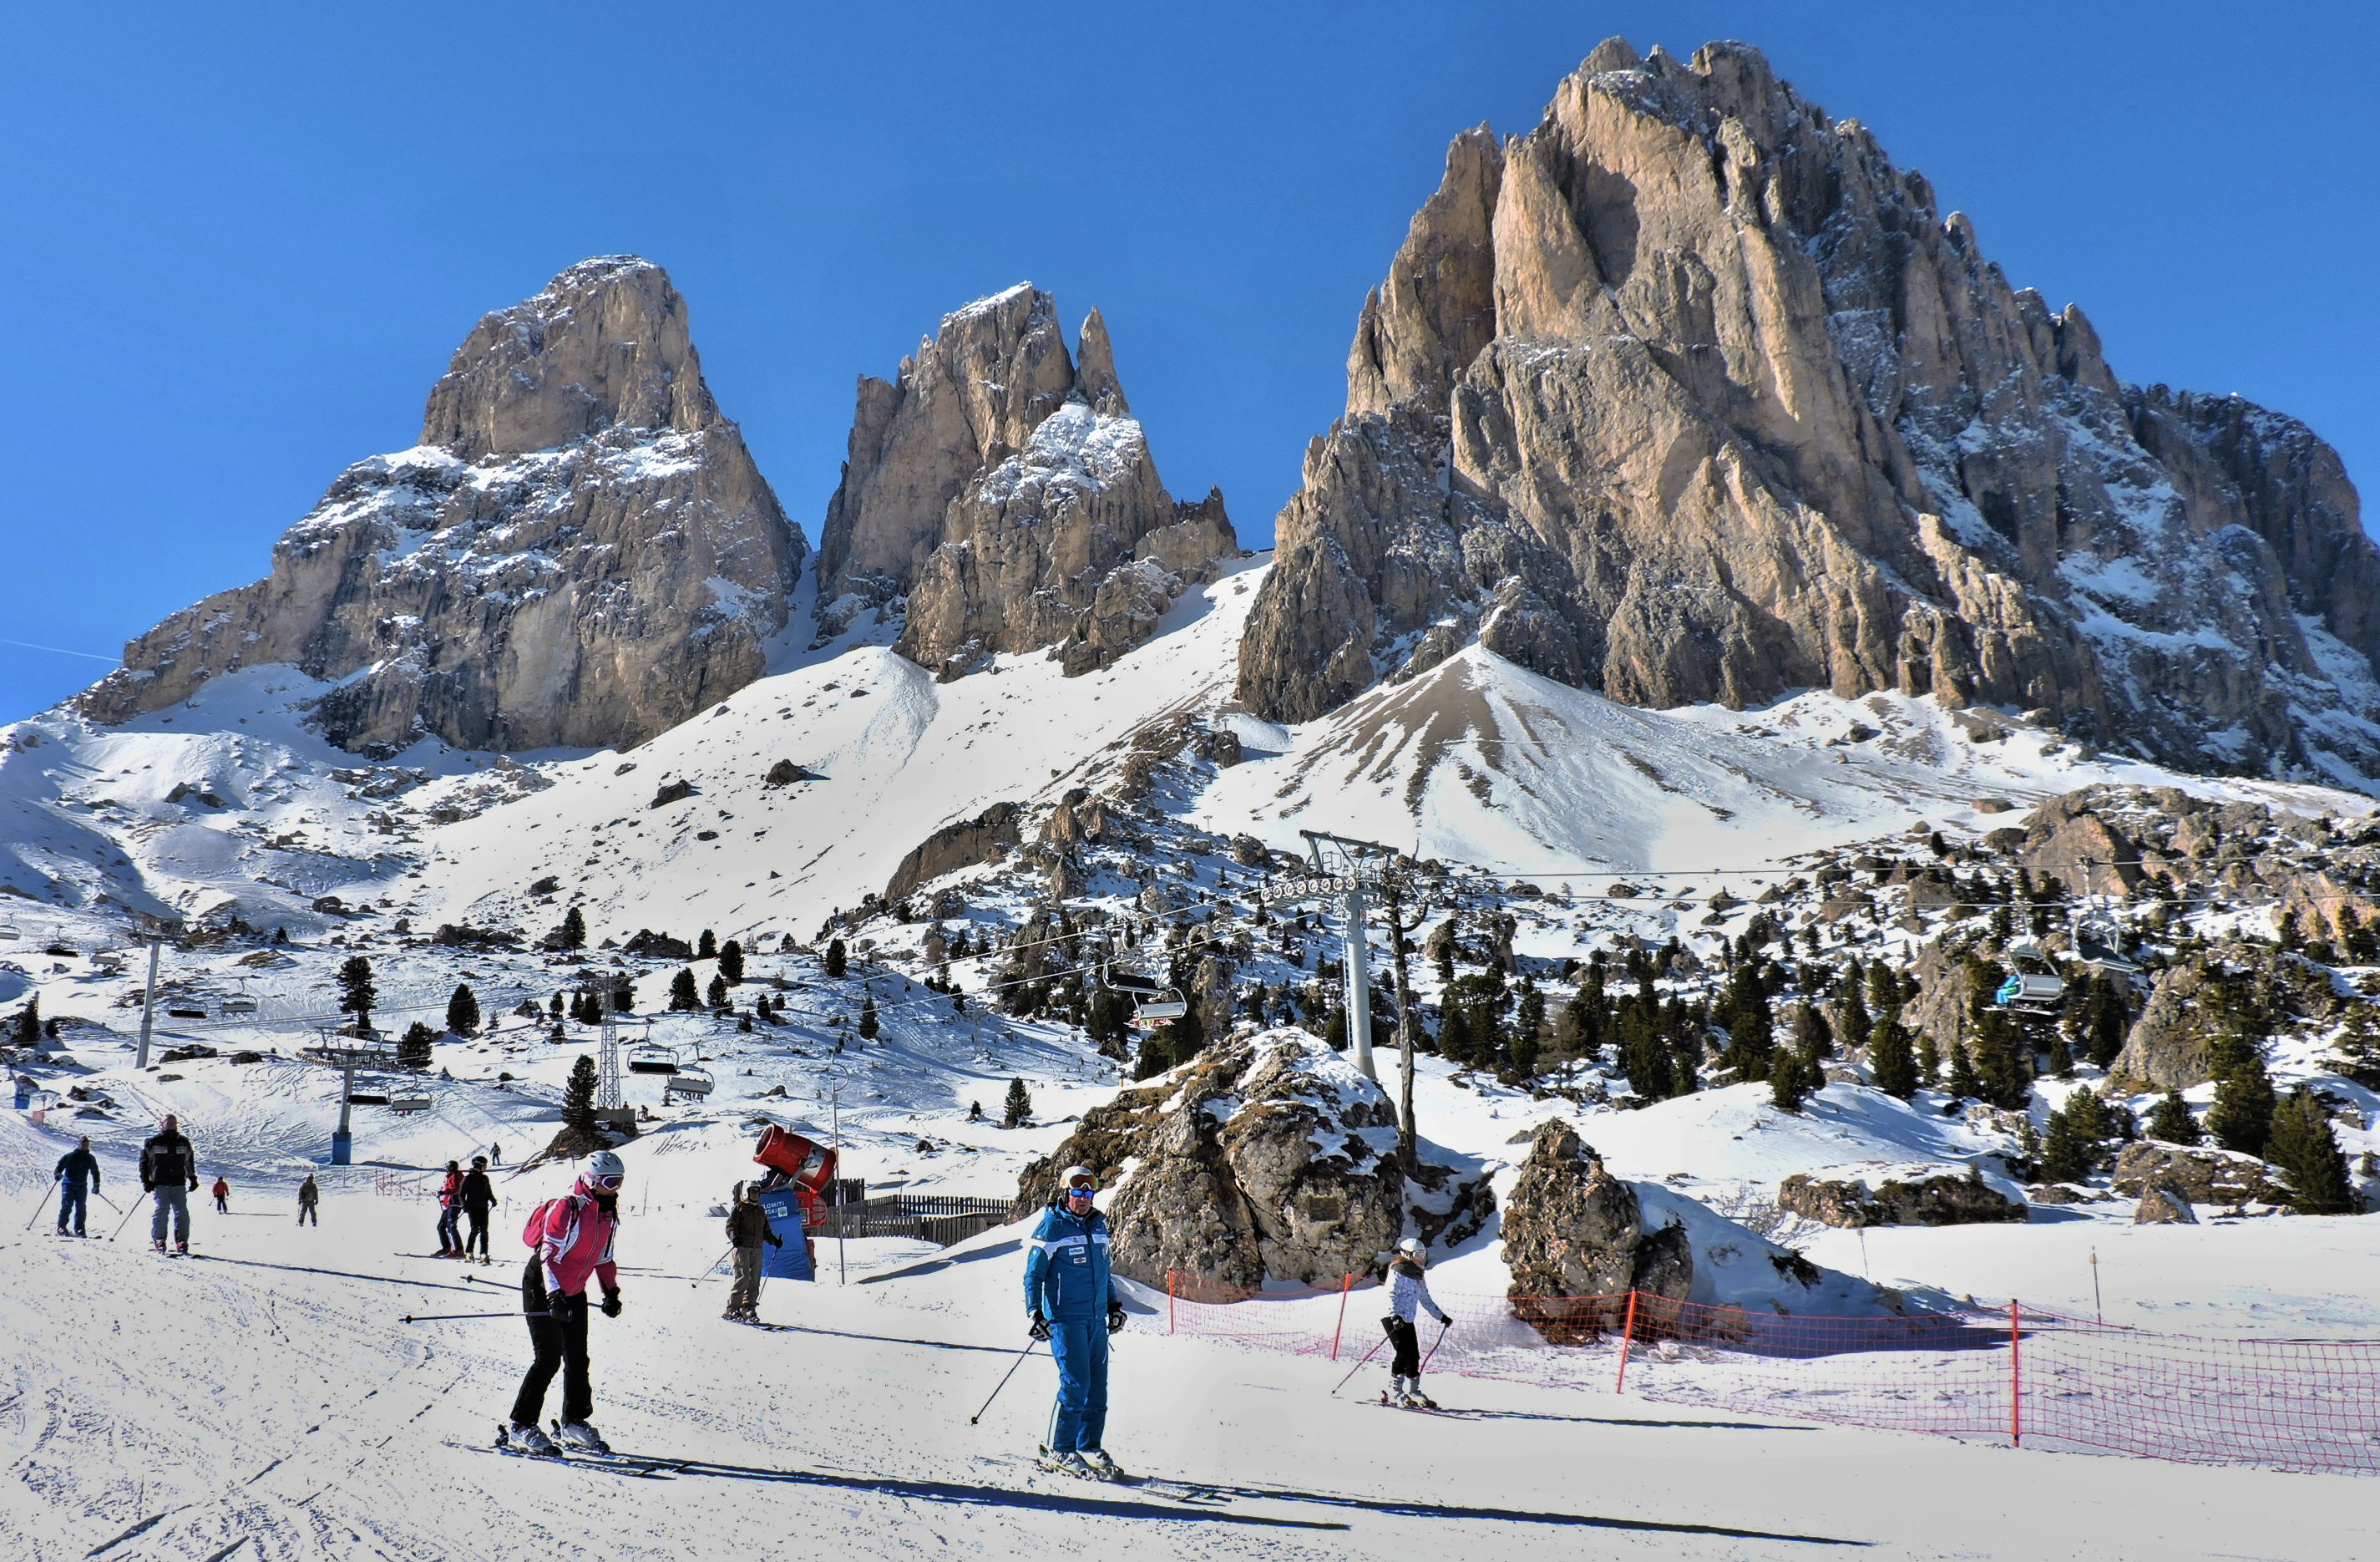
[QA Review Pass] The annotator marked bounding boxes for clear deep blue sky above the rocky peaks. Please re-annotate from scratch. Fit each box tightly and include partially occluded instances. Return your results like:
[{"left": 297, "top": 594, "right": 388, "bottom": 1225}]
[{"left": 0, "top": 0, "right": 2380, "bottom": 722}]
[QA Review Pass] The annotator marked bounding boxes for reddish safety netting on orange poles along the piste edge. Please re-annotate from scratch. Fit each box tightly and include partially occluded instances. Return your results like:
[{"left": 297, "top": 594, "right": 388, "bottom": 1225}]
[{"left": 1167, "top": 1274, "right": 2380, "bottom": 1474}]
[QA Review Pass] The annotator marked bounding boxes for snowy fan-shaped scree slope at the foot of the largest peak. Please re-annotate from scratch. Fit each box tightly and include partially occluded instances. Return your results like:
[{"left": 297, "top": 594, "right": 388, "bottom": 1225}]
[{"left": 1193, "top": 646, "right": 2371, "bottom": 876}]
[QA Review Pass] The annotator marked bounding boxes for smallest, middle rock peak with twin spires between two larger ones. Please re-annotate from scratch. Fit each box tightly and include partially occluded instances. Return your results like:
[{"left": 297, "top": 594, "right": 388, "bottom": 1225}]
[{"left": 818, "top": 286, "right": 1238, "bottom": 678}]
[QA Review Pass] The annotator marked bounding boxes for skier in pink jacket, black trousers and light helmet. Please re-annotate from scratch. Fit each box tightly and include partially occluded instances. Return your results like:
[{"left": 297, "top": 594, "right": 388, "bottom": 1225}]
[{"left": 504, "top": 1150, "right": 626, "bottom": 1455}]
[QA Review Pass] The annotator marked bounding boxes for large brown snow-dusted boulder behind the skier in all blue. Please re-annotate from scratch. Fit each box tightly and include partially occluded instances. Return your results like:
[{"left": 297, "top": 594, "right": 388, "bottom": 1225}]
[{"left": 1016, "top": 1028, "right": 1405, "bottom": 1288}]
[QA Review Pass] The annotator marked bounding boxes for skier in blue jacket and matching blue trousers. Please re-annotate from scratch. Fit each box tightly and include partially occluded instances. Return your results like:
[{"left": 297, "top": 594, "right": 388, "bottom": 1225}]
[{"left": 1025, "top": 1167, "right": 1123, "bottom": 1481}]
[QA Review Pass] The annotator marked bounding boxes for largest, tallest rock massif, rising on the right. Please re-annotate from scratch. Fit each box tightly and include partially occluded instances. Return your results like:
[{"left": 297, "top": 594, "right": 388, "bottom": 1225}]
[{"left": 1240, "top": 40, "right": 2380, "bottom": 778}]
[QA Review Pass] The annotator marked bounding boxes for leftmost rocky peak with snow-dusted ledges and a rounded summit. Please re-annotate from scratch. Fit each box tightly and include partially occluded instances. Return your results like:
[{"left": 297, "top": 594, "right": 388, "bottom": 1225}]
[{"left": 81, "top": 255, "right": 807, "bottom": 750}]
